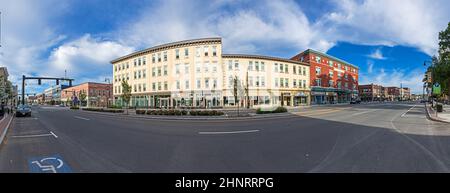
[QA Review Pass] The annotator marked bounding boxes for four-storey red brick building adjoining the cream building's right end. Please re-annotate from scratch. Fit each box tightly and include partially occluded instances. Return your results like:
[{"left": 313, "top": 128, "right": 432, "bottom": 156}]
[{"left": 291, "top": 49, "right": 359, "bottom": 104}]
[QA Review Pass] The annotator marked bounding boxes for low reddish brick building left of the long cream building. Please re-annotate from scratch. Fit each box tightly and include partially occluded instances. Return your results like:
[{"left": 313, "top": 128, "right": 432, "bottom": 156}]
[{"left": 61, "top": 82, "right": 113, "bottom": 107}]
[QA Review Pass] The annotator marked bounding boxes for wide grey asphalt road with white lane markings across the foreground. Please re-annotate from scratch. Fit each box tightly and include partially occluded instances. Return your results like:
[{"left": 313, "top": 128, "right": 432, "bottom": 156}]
[{"left": 0, "top": 103, "right": 450, "bottom": 172}]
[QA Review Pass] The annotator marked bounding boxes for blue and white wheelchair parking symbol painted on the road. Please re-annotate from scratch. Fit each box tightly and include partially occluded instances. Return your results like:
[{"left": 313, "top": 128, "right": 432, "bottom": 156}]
[{"left": 28, "top": 155, "right": 72, "bottom": 173}]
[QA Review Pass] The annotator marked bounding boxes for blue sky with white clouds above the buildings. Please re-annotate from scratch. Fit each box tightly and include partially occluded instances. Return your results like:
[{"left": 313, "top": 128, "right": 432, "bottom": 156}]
[{"left": 0, "top": 0, "right": 450, "bottom": 93}]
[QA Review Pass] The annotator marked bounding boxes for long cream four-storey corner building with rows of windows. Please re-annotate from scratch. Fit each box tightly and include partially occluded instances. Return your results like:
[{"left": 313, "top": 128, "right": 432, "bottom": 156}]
[{"left": 111, "top": 38, "right": 310, "bottom": 108}]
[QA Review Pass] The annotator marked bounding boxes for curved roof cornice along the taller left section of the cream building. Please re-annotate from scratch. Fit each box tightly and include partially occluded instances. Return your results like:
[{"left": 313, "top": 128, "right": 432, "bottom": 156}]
[{"left": 111, "top": 37, "right": 222, "bottom": 63}]
